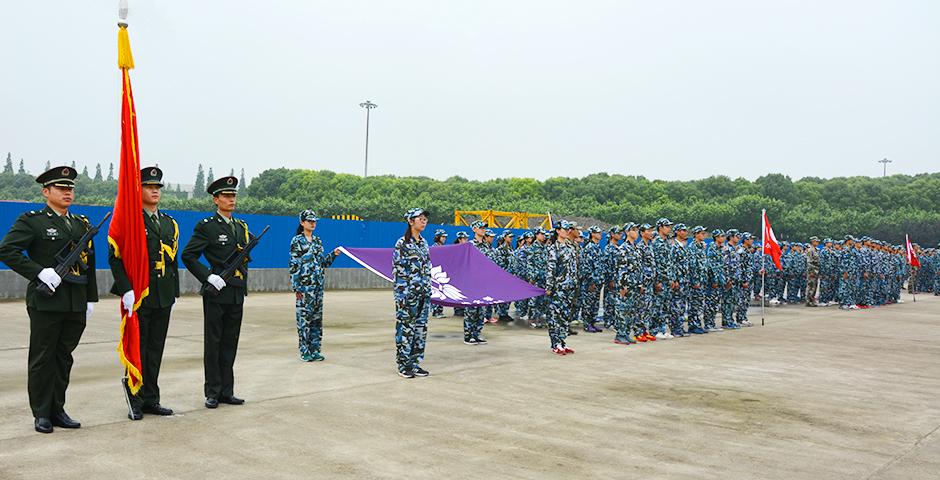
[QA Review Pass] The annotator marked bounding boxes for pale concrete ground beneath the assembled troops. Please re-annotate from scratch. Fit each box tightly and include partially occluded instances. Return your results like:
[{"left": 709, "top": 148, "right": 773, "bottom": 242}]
[{"left": 0, "top": 290, "right": 940, "bottom": 480}]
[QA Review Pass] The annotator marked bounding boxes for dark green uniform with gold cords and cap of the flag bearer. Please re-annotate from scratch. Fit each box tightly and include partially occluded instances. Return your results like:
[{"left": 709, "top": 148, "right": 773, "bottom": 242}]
[{"left": 108, "top": 167, "right": 180, "bottom": 415}]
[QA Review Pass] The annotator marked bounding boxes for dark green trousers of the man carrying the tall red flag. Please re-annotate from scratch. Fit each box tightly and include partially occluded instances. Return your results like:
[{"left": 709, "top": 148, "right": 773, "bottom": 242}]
[{"left": 130, "top": 307, "right": 172, "bottom": 408}]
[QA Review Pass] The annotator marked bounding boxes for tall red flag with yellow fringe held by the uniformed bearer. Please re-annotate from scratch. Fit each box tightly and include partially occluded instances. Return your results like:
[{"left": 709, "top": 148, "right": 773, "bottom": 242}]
[{"left": 108, "top": 24, "right": 150, "bottom": 394}]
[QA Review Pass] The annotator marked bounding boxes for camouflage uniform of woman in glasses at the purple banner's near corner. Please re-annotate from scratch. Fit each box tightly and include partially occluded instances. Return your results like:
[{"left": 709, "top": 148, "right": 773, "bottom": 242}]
[{"left": 392, "top": 223, "right": 431, "bottom": 373}]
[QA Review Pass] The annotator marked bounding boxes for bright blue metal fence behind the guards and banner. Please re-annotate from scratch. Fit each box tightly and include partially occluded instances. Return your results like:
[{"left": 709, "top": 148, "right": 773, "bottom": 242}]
[{"left": 0, "top": 202, "right": 520, "bottom": 269}]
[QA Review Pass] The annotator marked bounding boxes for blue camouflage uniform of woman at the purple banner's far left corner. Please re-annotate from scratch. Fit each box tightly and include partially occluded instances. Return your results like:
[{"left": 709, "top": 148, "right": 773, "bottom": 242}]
[{"left": 290, "top": 227, "right": 336, "bottom": 360}]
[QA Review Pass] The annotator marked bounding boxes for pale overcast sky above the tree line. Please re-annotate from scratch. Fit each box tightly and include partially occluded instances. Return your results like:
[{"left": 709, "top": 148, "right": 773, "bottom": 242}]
[{"left": 0, "top": 0, "right": 940, "bottom": 183}]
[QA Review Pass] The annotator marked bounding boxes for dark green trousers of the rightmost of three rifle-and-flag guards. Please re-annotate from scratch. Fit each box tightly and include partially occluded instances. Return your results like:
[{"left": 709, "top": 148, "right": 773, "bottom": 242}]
[{"left": 202, "top": 297, "right": 242, "bottom": 399}]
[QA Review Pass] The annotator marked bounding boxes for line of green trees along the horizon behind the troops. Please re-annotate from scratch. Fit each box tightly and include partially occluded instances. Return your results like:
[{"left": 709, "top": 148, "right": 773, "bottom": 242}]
[{"left": 0, "top": 152, "right": 940, "bottom": 246}]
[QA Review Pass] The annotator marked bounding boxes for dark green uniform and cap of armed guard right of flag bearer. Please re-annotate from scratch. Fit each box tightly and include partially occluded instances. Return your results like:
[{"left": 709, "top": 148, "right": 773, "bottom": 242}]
[{"left": 181, "top": 177, "right": 249, "bottom": 408}]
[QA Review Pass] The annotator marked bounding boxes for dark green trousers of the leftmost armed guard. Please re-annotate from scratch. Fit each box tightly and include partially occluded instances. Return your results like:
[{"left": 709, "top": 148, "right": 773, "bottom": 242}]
[{"left": 26, "top": 308, "right": 85, "bottom": 418}]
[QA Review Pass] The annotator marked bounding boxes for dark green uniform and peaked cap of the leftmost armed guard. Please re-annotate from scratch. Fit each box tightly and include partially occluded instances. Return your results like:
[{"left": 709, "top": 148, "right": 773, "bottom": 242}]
[{"left": 0, "top": 167, "right": 98, "bottom": 431}]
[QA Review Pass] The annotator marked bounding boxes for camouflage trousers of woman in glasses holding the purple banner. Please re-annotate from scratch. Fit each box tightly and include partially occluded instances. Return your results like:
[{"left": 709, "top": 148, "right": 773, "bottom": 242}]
[{"left": 395, "top": 292, "right": 431, "bottom": 372}]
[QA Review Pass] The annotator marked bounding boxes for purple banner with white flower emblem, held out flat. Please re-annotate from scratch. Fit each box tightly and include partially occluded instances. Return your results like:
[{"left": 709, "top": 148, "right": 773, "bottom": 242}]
[{"left": 340, "top": 243, "right": 545, "bottom": 307}]
